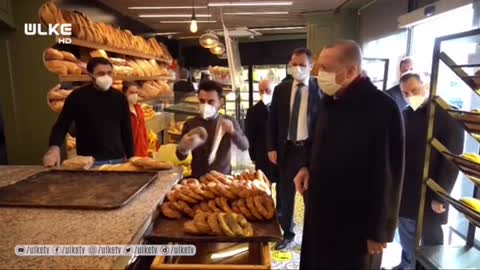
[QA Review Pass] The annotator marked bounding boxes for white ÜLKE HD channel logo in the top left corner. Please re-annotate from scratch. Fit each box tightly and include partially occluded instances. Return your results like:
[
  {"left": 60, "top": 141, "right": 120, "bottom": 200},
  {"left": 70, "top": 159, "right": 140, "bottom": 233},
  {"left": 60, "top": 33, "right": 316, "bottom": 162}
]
[{"left": 24, "top": 23, "right": 72, "bottom": 44}]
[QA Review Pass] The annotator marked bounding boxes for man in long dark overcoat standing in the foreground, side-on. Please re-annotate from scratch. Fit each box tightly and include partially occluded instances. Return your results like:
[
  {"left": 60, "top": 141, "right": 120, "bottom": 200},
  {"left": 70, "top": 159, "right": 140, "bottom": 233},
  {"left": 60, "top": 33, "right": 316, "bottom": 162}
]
[{"left": 295, "top": 41, "right": 405, "bottom": 270}]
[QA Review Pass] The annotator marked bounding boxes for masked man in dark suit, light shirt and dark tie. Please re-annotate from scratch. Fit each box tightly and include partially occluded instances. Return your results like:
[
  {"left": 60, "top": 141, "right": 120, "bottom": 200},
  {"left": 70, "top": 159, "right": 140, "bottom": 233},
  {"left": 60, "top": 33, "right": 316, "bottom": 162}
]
[{"left": 267, "top": 48, "right": 320, "bottom": 249}]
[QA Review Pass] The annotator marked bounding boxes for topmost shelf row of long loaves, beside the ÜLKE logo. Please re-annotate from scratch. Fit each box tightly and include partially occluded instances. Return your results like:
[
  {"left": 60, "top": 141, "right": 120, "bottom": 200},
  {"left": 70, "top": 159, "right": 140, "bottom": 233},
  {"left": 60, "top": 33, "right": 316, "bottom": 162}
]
[{"left": 39, "top": 1, "right": 172, "bottom": 60}]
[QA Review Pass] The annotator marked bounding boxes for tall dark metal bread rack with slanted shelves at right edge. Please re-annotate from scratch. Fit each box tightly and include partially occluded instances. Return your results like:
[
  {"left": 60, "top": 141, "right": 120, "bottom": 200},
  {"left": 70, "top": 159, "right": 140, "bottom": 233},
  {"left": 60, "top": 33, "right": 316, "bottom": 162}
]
[{"left": 416, "top": 29, "right": 480, "bottom": 269}]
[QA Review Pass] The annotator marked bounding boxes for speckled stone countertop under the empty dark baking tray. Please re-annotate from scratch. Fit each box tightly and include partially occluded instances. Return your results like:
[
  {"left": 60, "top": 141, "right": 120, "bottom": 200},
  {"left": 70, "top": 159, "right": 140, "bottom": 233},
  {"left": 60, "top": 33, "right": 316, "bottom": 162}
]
[{"left": 0, "top": 166, "right": 180, "bottom": 269}]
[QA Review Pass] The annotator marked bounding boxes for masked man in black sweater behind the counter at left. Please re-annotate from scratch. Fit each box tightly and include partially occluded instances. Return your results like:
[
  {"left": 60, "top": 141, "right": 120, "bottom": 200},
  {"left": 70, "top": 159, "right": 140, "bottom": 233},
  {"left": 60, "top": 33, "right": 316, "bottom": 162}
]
[{"left": 43, "top": 57, "right": 134, "bottom": 167}]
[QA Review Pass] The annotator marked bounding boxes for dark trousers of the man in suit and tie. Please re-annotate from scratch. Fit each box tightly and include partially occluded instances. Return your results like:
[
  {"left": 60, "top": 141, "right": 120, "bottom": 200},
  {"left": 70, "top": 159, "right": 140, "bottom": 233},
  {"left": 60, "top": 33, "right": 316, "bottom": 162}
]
[{"left": 277, "top": 143, "right": 307, "bottom": 239}]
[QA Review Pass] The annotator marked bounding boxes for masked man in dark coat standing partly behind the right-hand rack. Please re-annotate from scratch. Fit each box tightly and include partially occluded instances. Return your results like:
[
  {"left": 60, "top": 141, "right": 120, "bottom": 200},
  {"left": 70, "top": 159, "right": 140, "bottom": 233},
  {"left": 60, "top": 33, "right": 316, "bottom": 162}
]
[{"left": 394, "top": 72, "right": 464, "bottom": 269}]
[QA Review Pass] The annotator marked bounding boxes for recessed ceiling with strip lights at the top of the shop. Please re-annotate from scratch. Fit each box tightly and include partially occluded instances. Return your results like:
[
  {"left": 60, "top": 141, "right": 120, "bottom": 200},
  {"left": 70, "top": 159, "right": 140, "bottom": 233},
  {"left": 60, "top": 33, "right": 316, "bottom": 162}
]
[{"left": 99, "top": 0, "right": 374, "bottom": 37}]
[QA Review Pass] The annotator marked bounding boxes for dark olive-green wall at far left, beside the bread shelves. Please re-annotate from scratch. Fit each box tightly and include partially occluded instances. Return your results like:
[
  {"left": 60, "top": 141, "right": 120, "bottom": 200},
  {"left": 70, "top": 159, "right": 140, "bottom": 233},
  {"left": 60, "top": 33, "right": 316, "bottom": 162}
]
[{"left": 0, "top": 0, "right": 58, "bottom": 164}]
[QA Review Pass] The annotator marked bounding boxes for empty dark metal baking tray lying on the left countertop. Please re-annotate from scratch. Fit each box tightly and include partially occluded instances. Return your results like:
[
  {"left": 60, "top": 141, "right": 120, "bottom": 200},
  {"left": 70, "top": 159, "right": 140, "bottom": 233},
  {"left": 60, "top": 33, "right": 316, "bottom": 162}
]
[{"left": 0, "top": 170, "right": 158, "bottom": 210}]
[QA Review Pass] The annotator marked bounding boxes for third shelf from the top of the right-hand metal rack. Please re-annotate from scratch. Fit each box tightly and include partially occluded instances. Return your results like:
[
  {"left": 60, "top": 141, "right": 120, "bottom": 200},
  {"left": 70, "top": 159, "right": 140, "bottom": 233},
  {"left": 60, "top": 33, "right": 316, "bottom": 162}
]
[{"left": 431, "top": 138, "right": 480, "bottom": 187}]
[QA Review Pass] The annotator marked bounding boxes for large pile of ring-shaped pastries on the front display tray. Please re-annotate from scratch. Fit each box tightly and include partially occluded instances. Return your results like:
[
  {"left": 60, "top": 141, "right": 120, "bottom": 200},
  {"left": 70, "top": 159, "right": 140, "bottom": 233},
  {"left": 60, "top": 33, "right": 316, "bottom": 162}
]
[{"left": 160, "top": 170, "right": 275, "bottom": 237}]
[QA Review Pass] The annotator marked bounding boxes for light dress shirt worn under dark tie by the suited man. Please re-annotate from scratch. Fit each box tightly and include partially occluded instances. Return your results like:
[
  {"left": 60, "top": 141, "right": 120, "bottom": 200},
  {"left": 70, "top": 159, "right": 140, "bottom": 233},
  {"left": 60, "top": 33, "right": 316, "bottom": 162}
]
[{"left": 288, "top": 78, "right": 310, "bottom": 141}]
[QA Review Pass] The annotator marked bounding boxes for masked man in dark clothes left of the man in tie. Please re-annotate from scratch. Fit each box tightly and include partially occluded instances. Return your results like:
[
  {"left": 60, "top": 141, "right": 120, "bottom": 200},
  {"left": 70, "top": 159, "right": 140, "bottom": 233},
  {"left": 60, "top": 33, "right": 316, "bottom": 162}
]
[{"left": 245, "top": 80, "right": 278, "bottom": 182}]
